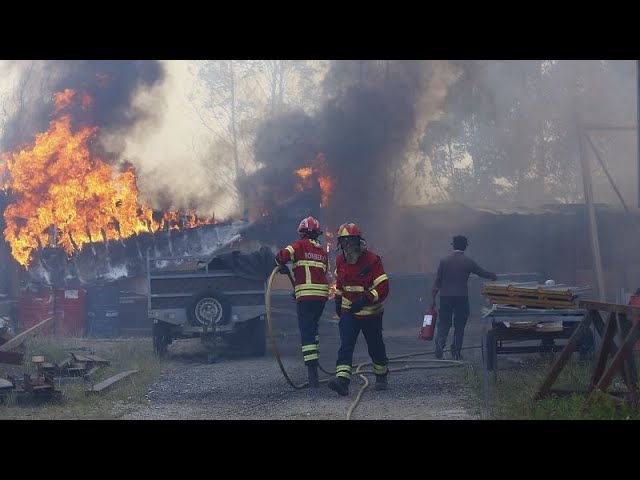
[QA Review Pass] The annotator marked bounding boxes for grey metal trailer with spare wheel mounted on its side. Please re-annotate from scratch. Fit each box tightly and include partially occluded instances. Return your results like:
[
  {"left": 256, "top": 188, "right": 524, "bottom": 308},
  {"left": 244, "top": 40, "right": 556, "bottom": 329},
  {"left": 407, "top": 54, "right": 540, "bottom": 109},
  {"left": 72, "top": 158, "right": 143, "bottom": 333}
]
[{"left": 147, "top": 254, "right": 266, "bottom": 362}]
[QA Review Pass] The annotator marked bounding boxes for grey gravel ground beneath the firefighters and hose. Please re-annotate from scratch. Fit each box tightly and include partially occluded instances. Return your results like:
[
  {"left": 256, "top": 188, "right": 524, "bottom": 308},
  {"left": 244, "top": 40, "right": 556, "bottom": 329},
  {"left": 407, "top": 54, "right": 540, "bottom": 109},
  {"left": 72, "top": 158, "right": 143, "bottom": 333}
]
[{"left": 121, "top": 319, "right": 480, "bottom": 420}]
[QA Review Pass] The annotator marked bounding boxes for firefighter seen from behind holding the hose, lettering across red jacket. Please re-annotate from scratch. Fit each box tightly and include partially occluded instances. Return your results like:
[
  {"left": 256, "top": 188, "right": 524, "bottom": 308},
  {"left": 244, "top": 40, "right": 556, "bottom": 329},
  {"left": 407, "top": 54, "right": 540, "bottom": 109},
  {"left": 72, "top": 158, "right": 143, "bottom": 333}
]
[{"left": 276, "top": 217, "right": 329, "bottom": 388}]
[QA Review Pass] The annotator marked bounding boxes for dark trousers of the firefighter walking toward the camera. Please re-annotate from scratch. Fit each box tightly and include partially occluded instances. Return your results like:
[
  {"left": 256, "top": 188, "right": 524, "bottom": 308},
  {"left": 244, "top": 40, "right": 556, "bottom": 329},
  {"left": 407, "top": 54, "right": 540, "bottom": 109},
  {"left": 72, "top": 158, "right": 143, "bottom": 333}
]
[{"left": 336, "top": 312, "right": 389, "bottom": 380}]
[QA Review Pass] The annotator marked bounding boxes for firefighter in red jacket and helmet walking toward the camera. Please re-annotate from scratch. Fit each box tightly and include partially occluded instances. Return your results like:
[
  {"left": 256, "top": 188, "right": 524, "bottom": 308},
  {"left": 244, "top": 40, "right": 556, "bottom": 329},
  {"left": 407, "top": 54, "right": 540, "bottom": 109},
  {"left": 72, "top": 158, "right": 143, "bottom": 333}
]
[{"left": 329, "top": 223, "right": 389, "bottom": 396}]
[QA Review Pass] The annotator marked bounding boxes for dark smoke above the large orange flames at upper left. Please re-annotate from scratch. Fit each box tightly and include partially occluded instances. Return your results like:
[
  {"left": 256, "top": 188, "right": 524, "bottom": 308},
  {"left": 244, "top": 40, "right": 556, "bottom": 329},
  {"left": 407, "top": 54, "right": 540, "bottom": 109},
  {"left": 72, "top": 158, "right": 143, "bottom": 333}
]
[{"left": 0, "top": 60, "right": 165, "bottom": 150}]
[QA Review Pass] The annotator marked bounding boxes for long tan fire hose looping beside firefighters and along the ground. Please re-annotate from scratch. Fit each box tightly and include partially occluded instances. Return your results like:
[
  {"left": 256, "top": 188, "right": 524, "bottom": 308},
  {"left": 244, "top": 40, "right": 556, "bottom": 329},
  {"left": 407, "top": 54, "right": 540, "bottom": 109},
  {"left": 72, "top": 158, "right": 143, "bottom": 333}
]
[{"left": 266, "top": 266, "right": 479, "bottom": 420}]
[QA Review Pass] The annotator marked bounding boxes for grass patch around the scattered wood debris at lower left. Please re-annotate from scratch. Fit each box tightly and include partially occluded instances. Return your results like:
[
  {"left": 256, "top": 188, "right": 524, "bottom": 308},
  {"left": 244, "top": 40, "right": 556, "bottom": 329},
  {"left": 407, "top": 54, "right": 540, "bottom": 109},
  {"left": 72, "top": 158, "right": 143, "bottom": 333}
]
[{"left": 0, "top": 337, "right": 165, "bottom": 420}]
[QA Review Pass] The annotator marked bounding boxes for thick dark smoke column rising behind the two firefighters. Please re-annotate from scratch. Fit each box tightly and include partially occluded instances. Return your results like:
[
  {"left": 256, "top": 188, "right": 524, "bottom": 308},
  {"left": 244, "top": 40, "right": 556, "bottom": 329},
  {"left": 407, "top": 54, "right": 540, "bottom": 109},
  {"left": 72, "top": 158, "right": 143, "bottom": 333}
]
[{"left": 249, "top": 61, "right": 427, "bottom": 233}]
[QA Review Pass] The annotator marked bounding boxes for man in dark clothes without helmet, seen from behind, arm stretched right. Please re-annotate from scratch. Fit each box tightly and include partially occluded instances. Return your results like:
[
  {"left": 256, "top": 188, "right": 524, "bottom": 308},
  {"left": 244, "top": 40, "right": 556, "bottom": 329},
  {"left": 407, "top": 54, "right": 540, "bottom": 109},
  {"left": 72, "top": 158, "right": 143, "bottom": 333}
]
[{"left": 431, "top": 235, "right": 498, "bottom": 360}]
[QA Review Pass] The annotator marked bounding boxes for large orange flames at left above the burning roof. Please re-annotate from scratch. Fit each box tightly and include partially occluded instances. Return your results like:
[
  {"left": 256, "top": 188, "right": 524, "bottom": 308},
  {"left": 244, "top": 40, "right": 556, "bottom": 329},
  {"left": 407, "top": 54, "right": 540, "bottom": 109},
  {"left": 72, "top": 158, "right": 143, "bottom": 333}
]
[{"left": 0, "top": 89, "right": 212, "bottom": 267}]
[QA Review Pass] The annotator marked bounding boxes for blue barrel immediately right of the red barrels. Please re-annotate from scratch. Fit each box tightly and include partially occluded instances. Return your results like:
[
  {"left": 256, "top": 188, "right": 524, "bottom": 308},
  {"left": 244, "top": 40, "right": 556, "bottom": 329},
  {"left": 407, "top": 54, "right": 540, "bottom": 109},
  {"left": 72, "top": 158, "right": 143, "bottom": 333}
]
[{"left": 87, "top": 285, "right": 120, "bottom": 337}]
